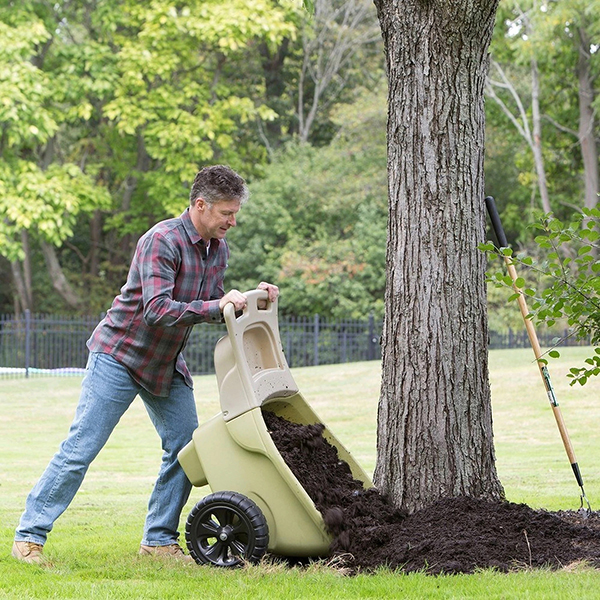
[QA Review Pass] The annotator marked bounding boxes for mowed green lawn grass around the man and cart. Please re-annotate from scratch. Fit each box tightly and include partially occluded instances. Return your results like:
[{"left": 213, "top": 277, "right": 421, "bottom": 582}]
[{"left": 0, "top": 348, "right": 600, "bottom": 599}]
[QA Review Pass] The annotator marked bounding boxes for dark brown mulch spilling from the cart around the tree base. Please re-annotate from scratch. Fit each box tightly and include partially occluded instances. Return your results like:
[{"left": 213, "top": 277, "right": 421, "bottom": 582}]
[{"left": 263, "top": 411, "right": 600, "bottom": 574}]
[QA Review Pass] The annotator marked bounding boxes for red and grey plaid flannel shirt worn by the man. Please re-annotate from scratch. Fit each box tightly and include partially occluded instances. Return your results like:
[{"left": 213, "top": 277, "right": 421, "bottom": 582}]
[{"left": 87, "top": 209, "right": 229, "bottom": 396}]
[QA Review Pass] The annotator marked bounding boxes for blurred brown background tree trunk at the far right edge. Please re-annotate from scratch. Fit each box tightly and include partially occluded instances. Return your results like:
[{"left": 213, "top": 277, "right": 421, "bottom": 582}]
[{"left": 577, "top": 27, "right": 599, "bottom": 208}]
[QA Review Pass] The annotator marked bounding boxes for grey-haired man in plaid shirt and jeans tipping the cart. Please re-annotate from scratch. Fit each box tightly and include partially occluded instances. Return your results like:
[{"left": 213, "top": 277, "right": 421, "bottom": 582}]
[{"left": 12, "top": 165, "right": 279, "bottom": 563}]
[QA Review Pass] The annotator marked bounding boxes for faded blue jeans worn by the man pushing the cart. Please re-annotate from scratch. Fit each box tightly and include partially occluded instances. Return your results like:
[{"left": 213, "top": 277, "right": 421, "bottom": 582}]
[{"left": 15, "top": 352, "right": 198, "bottom": 546}]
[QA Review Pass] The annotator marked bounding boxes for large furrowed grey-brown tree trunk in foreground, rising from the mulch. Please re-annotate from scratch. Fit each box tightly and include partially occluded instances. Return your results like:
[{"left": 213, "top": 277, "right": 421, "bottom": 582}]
[{"left": 375, "top": 0, "right": 503, "bottom": 512}]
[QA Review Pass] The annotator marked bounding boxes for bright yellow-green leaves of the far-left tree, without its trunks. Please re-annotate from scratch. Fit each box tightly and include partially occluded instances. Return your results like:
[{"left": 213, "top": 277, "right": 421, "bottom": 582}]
[{"left": 0, "top": 11, "right": 109, "bottom": 260}]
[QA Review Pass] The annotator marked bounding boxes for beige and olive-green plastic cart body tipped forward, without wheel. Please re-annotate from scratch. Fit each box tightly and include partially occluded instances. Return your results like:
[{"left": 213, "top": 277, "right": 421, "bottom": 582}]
[{"left": 179, "top": 290, "right": 372, "bottom": 557}]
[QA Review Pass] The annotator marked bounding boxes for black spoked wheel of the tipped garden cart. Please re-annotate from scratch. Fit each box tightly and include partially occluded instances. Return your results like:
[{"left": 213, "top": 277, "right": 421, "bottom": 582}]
[{"left": 185, "top": 492, "right": 269, "bottom": 567}]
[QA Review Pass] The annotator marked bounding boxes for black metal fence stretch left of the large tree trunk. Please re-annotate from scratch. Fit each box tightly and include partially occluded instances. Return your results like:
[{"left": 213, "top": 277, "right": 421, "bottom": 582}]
[{"left": 0, "top": 311, "right": 381, "bottom": 378}]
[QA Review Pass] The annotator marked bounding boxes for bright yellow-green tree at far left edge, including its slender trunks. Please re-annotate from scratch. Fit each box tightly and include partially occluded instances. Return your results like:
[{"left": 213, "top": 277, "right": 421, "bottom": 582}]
[{"left": 0, "top": 10, "right": 108, "bottom": 309}]
